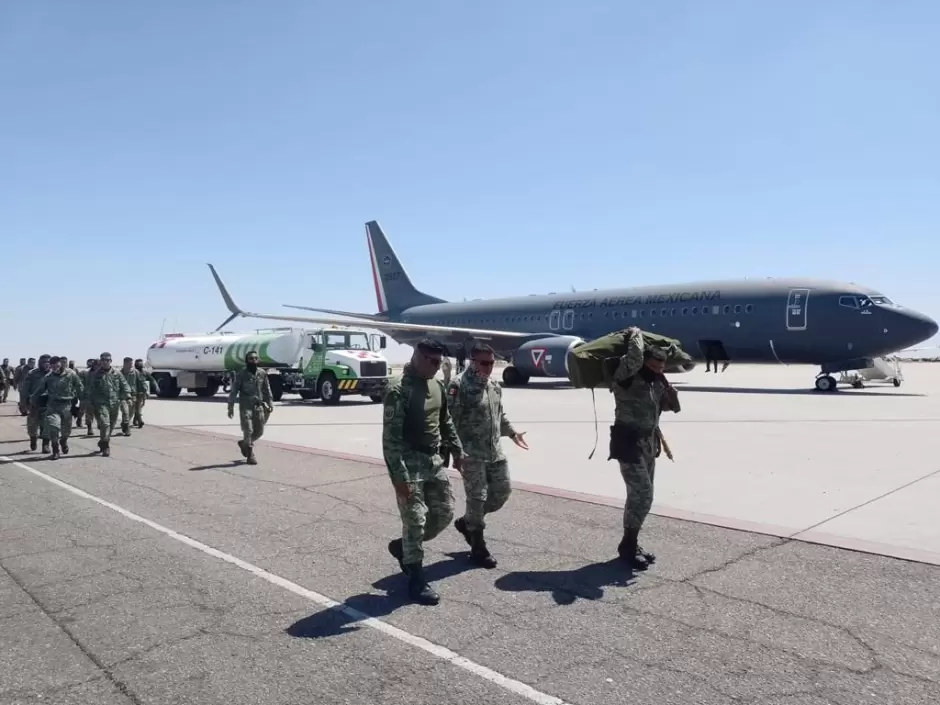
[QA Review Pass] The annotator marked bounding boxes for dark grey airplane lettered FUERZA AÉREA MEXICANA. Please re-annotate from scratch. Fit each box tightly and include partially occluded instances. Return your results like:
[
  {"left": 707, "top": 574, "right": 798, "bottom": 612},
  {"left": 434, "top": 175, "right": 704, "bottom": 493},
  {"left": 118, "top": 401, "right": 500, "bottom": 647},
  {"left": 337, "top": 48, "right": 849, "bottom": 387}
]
[{"left": 208, "top": 220, "right": 938, "bottom": 392}]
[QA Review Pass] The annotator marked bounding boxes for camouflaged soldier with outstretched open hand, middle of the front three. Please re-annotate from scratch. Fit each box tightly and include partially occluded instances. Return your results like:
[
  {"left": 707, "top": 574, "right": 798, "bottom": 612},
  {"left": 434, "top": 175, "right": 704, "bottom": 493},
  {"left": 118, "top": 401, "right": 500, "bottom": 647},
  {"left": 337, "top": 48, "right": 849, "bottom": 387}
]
[{"left": 447, "top": 344, "right": 529, "bottom": 568}]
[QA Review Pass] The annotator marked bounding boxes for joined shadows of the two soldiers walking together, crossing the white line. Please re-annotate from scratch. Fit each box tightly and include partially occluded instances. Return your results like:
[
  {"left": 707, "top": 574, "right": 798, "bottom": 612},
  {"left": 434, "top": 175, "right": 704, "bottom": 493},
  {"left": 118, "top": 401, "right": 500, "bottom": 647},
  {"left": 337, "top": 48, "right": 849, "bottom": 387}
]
[{"left": 284, "top": 552, "right": 473, "bottom": 639}]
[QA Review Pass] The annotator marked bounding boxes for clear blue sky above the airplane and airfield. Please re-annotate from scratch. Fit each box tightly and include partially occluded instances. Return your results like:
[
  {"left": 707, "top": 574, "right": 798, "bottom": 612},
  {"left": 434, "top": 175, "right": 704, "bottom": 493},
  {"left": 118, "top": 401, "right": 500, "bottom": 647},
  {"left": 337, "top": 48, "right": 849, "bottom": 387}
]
[{"left": 0, "top": 0, "right": 940, "bottom": 359}]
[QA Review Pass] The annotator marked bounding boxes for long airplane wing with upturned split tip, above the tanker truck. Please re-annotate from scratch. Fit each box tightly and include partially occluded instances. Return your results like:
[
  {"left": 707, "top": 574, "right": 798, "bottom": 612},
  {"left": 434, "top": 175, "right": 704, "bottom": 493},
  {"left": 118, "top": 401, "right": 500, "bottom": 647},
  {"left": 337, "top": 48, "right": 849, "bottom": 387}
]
[{"left": 209, "top": 264, "right": 544, "bottom": 351}]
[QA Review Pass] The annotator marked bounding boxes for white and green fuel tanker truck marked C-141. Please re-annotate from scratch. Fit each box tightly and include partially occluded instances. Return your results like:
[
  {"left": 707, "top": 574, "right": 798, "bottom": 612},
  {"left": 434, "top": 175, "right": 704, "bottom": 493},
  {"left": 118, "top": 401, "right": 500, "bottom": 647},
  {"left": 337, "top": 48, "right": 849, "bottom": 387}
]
[{"left": 147, "top": 326, "right": 389, "bottom": 404}]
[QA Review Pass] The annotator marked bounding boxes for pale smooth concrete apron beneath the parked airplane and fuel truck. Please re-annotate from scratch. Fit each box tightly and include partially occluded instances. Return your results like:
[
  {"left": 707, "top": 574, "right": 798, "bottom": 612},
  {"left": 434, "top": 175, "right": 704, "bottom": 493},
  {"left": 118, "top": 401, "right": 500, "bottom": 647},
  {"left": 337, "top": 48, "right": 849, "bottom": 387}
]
[{"left": 147, "top": 363, "right": 940, "bottom": 564}]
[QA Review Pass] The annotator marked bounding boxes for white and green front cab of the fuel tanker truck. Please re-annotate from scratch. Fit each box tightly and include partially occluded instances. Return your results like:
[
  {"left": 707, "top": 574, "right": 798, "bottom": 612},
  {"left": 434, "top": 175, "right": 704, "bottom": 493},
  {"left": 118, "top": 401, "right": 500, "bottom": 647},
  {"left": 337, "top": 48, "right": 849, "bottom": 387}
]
[{"left": 298, "top": 326, "right": 389, "bottom": 404}]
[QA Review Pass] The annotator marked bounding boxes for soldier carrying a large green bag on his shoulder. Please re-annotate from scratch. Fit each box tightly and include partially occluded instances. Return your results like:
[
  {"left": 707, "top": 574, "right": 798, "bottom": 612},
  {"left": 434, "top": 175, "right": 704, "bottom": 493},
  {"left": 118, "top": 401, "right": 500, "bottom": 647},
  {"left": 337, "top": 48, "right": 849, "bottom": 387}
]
[{"left": 609, "top": 327, "right": 680, "bottom": 570}]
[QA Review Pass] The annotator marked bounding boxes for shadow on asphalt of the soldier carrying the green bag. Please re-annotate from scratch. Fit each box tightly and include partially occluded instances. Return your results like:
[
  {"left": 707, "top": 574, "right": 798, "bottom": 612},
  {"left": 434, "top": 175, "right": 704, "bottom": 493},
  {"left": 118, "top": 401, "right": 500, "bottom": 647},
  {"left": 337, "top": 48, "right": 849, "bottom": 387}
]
[{"left": 494, "top": 558, "right": 636, "bottom": 605}]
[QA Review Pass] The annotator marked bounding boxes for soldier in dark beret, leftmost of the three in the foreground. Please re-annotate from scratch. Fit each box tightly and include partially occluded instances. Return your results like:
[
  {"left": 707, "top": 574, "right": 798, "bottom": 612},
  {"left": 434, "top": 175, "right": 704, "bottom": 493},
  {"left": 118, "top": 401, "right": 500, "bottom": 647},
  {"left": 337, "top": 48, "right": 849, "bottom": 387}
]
[{"left": 382, "top": 340, "right": 463, "bottom": 605}]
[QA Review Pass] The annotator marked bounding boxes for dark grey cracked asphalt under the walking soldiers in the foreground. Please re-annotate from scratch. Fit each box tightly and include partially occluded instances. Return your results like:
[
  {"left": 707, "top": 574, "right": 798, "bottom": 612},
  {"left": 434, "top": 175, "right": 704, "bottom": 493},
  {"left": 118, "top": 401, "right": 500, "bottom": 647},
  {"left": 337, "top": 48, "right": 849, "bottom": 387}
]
[{"left": 0, "top": 396, "right": 940, "bottom": 705}]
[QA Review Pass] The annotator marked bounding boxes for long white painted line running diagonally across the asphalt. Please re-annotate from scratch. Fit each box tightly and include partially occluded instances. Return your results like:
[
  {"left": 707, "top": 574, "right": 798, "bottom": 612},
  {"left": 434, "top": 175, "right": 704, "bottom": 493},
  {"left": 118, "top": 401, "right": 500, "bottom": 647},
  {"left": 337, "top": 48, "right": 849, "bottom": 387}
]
[{"left": 0, "top": 456, "right": 571, "bottom": 705}]
